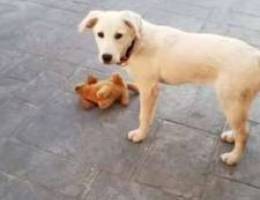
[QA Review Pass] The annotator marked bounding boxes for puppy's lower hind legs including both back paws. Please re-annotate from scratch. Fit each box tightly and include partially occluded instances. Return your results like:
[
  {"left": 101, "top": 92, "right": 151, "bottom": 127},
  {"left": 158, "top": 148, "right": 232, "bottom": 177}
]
[{"left": 217, "top": 82, "right": 254, "bottom": 165}]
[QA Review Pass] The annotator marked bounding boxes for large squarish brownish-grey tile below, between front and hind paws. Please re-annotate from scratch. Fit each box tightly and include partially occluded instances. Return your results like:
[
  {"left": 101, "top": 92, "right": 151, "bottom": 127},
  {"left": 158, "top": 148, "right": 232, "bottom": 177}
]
[{"left": 135, "top": 122, "right": 215, "bottom": 199}]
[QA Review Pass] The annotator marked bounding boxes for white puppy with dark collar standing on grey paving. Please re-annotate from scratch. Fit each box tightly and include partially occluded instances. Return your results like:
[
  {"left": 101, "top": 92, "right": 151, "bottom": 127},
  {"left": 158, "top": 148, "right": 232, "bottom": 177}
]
[{"left": 79, "top": 11, "right": 260, "bottom": 165}]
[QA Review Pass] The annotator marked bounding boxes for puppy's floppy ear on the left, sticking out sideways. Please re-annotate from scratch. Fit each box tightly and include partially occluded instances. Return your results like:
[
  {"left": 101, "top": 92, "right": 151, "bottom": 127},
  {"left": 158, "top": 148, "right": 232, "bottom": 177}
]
[{"left": 78, "top": 10, "right": 102, "bottom": 33}]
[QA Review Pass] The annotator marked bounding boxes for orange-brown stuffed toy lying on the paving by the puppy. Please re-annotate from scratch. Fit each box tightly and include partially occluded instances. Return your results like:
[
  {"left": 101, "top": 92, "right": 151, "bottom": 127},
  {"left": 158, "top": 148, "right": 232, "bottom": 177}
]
[{"left": 75, "top": 74, "right": 138, "bottom": 109}]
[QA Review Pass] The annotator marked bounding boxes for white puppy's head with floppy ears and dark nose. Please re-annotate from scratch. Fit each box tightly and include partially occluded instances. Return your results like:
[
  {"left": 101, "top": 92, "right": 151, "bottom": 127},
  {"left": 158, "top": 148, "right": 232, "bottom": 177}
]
[{"left": 79, "top": 11, "right": 142, "bottom": 64}]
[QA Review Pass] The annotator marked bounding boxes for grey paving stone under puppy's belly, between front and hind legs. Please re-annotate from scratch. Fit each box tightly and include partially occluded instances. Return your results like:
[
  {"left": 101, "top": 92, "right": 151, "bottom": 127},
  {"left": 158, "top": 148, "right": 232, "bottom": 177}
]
[{"left": 158, "top": 85, "right": 225, "bottom": 133}]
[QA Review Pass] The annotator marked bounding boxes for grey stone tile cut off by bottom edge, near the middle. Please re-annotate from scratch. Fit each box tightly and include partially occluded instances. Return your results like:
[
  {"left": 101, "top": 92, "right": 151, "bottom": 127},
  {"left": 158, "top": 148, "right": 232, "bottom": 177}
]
[{"left": 85, "top": 173, "right": 182, "bottom": 200}]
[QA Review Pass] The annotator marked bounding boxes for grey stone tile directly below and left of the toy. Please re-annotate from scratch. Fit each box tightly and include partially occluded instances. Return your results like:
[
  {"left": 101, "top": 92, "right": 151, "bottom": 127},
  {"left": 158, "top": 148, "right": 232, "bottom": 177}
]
[{"left": 16, "top": 92, "right": 83, "bottom": 157}]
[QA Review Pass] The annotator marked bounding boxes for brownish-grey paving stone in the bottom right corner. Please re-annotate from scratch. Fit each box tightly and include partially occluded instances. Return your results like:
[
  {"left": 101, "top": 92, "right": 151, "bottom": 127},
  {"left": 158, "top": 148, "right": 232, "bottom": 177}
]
[{"left": 202, "top": 176, "right": 260, "bottom": 200}]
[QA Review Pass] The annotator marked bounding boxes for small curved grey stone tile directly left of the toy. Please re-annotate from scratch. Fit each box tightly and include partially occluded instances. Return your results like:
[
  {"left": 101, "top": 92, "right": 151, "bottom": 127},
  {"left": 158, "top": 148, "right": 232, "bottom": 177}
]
[{"left": 14, "top": 72, "right": 71, "bottom": 106}]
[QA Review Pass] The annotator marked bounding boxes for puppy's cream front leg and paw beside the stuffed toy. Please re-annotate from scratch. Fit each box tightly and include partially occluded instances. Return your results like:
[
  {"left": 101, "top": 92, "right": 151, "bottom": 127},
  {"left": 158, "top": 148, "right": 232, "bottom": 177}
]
[{"left": 128, "top": 84, "right": 159, "bottom": 143}]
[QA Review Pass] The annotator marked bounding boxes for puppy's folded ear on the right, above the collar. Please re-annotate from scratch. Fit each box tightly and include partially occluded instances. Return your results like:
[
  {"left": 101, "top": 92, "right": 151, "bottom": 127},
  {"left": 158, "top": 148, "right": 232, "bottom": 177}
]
[{"left": 122, "top": 10, "right": 142, "bottom": 39}]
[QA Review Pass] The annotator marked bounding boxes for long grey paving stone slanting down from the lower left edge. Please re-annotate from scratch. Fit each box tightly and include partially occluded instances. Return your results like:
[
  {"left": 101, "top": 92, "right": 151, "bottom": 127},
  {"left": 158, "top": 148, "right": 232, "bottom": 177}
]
[{"left": 0, "top": 139, "right": 97, "bottom": 197}]
